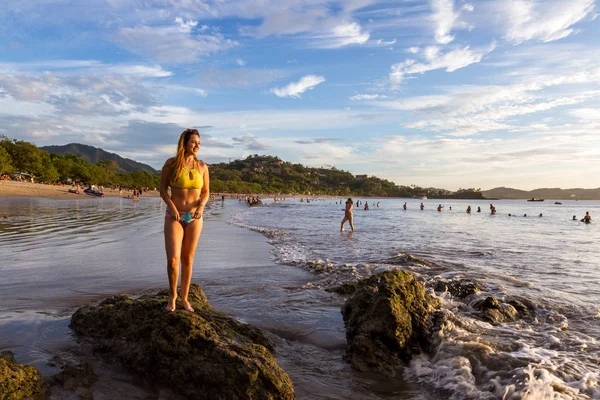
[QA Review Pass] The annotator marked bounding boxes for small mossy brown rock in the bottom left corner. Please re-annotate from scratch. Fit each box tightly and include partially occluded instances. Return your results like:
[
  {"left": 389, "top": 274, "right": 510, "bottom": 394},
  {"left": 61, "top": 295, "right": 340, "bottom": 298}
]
[{"left": 0, "top": 351, "right": 50, "bottom": 400}]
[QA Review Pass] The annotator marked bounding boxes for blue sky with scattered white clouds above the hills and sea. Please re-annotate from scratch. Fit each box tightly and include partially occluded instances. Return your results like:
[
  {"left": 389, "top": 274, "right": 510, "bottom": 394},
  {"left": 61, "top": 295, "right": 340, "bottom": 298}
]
[{"left": 0, "top": 0, "right": 600, "bottom": 190}]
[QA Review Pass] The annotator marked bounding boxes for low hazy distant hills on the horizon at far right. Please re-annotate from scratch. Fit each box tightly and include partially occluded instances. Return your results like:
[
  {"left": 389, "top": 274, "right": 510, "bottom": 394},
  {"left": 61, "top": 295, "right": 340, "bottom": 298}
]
[{"left": 482, "top": 187, "right": 600, "bottom": 200}]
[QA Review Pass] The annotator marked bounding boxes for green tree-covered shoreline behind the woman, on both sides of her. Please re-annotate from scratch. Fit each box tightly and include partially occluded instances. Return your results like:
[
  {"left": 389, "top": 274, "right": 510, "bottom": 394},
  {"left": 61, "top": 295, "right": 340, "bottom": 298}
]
[{"left": 0, "top": 136, "right": 482, "bottom": 198}]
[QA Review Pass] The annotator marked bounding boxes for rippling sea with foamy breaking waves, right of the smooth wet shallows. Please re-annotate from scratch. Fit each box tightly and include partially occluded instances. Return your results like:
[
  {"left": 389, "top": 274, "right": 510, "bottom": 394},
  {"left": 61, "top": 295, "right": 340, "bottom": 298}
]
[{"left": 233, "top": 199, "right": 600, "bottom": 398}]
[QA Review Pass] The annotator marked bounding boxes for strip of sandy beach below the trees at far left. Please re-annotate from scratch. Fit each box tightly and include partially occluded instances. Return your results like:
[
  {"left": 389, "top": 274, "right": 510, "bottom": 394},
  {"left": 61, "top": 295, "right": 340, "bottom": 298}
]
[{"left": 0, "top": 181, "right": 159, "bottom": 200}]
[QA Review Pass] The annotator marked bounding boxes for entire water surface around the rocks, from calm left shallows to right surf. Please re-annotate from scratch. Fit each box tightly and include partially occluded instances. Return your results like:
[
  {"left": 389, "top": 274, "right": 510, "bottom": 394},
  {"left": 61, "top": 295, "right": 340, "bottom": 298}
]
[{"left": 0, "top": 198, "right": 600, "bottom": 399}]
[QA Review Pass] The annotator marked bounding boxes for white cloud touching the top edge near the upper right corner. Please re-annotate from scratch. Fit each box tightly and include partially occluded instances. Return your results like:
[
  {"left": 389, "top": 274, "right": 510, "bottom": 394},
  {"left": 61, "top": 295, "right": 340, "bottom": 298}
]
[{"left": 498, "top": 0, "right": 595, "bottom": 44}]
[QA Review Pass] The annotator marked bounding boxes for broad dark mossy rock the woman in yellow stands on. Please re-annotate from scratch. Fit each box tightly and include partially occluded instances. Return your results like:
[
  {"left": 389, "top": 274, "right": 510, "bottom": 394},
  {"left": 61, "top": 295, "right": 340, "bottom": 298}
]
[{"left": 70, "top": 285, "right": 294, "bottom": 400}]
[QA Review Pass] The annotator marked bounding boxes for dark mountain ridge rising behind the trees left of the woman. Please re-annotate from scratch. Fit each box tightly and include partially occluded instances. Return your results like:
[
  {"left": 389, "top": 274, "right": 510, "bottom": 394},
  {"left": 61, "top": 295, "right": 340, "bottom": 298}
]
[{"left": 40, "top": 143, "right": 158, "bottom": 174}]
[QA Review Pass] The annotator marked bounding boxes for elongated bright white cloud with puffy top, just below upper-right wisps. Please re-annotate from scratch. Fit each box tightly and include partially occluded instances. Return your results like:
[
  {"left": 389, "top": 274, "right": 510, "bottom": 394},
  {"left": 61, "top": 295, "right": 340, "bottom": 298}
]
[{"left": 389, "top": 45, "right": 494, "bottom": 84}]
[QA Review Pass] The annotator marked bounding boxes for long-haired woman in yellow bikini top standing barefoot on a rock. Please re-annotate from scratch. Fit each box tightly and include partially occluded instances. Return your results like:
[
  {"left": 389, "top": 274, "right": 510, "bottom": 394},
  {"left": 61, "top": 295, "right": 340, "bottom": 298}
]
[{"left": 160, "top": 129, "right": 210, "bottom": 312}]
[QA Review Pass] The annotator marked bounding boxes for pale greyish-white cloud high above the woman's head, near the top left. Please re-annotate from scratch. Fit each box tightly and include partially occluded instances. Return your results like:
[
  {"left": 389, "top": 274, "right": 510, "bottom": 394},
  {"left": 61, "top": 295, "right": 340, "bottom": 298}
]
[{"left": 114, "top": 19, "right": 239, "bottom": 64}]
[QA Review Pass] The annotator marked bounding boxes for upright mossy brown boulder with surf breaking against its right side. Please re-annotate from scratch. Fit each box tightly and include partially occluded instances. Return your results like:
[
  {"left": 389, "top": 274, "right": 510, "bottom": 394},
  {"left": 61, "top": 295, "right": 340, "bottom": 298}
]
[{"left": 342, "top": 270, "right": 440, "bottom": 376}]
